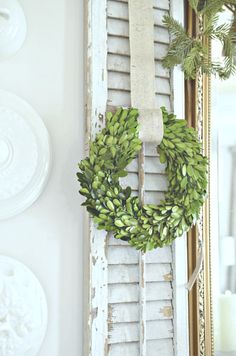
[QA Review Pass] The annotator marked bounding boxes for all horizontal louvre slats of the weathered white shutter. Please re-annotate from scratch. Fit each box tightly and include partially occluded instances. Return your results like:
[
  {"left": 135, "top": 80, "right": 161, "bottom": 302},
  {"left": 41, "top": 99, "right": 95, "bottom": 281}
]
[{"left": 107, "top": 1, "right": 173, "bottom": 350}]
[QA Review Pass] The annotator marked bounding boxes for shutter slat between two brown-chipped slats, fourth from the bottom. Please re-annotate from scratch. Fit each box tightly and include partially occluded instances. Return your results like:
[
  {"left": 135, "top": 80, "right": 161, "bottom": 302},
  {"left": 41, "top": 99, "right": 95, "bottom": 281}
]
[{"left": 108, "top": 282, "right": 172, "bottom": 303}]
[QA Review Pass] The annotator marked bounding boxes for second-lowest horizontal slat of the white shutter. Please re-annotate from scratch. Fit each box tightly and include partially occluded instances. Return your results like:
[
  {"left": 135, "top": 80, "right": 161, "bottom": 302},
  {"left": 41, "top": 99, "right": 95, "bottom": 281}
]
[{"left": 109, "top": 320, "right": 173, "bottom": 344}]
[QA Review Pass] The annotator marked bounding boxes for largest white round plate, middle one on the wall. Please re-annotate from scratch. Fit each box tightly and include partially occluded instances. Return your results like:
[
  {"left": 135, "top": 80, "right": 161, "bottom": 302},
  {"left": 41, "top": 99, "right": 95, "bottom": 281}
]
[{"left": 0, "top": 90, "right": 51, "bottom": 219}]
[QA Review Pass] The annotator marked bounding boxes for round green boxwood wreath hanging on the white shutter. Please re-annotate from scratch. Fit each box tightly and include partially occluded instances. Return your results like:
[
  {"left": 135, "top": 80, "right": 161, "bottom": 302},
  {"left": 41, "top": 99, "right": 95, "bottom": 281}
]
[{"left": 77, "top": 107, "right": 207, "bottom": 252}]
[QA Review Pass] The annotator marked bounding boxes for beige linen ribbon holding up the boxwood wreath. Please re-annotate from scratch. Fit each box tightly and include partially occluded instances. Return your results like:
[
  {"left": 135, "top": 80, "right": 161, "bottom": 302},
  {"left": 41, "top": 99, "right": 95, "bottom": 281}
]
[{"left": 129, "top": 0, "right": 163, "bottom": 144}]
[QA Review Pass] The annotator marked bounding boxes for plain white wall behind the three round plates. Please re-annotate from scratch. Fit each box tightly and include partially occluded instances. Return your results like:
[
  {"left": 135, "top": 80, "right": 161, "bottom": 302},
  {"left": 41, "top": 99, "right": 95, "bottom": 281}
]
[{"left": 0, "top": 0, "right": 84, "bottom": 356}]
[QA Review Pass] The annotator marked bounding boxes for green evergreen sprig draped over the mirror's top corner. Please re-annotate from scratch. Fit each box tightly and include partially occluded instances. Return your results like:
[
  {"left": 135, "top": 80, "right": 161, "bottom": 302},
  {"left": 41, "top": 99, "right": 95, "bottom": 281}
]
[{"left": 162, "top": 0, "right": 236, "bottom": 79}]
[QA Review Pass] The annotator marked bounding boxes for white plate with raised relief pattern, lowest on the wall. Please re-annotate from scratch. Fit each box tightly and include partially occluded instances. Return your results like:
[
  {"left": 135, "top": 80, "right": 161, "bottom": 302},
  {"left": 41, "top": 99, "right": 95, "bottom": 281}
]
[{"left": 0, "top": 256, "right": 48, "bottom": 356}]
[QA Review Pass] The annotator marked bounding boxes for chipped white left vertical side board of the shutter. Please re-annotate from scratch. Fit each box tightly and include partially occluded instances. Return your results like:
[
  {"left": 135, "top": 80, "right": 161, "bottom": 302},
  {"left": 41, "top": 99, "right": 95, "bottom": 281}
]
[{"left": 84, "top": 0, "right": 108, "bottom": 356}]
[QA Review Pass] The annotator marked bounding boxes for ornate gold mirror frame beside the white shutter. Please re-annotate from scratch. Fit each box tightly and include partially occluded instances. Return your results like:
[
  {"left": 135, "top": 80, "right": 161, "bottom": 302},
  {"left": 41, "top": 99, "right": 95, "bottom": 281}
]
[{"left": 185, "top": 1, "right": 214, "bottom": 356}]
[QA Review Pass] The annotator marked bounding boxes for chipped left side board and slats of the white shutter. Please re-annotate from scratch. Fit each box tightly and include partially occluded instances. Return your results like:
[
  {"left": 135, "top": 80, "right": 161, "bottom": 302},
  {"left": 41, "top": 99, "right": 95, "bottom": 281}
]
[{"left": 84, "top": 0, "right": 187, "bottom": 356}]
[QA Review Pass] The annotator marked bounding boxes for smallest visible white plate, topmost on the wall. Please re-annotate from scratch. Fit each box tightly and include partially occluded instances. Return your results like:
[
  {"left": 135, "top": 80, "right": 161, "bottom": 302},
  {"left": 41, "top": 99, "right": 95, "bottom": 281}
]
[{"left": 0, "top": 0, "right": 27, "bottom": 59}]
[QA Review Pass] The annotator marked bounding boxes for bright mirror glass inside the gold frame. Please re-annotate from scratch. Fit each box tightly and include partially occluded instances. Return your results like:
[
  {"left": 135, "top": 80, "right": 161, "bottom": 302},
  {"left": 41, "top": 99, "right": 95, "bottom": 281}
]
[{"left": 210, "top": 9, "right": 236, "bottom": 356}]
